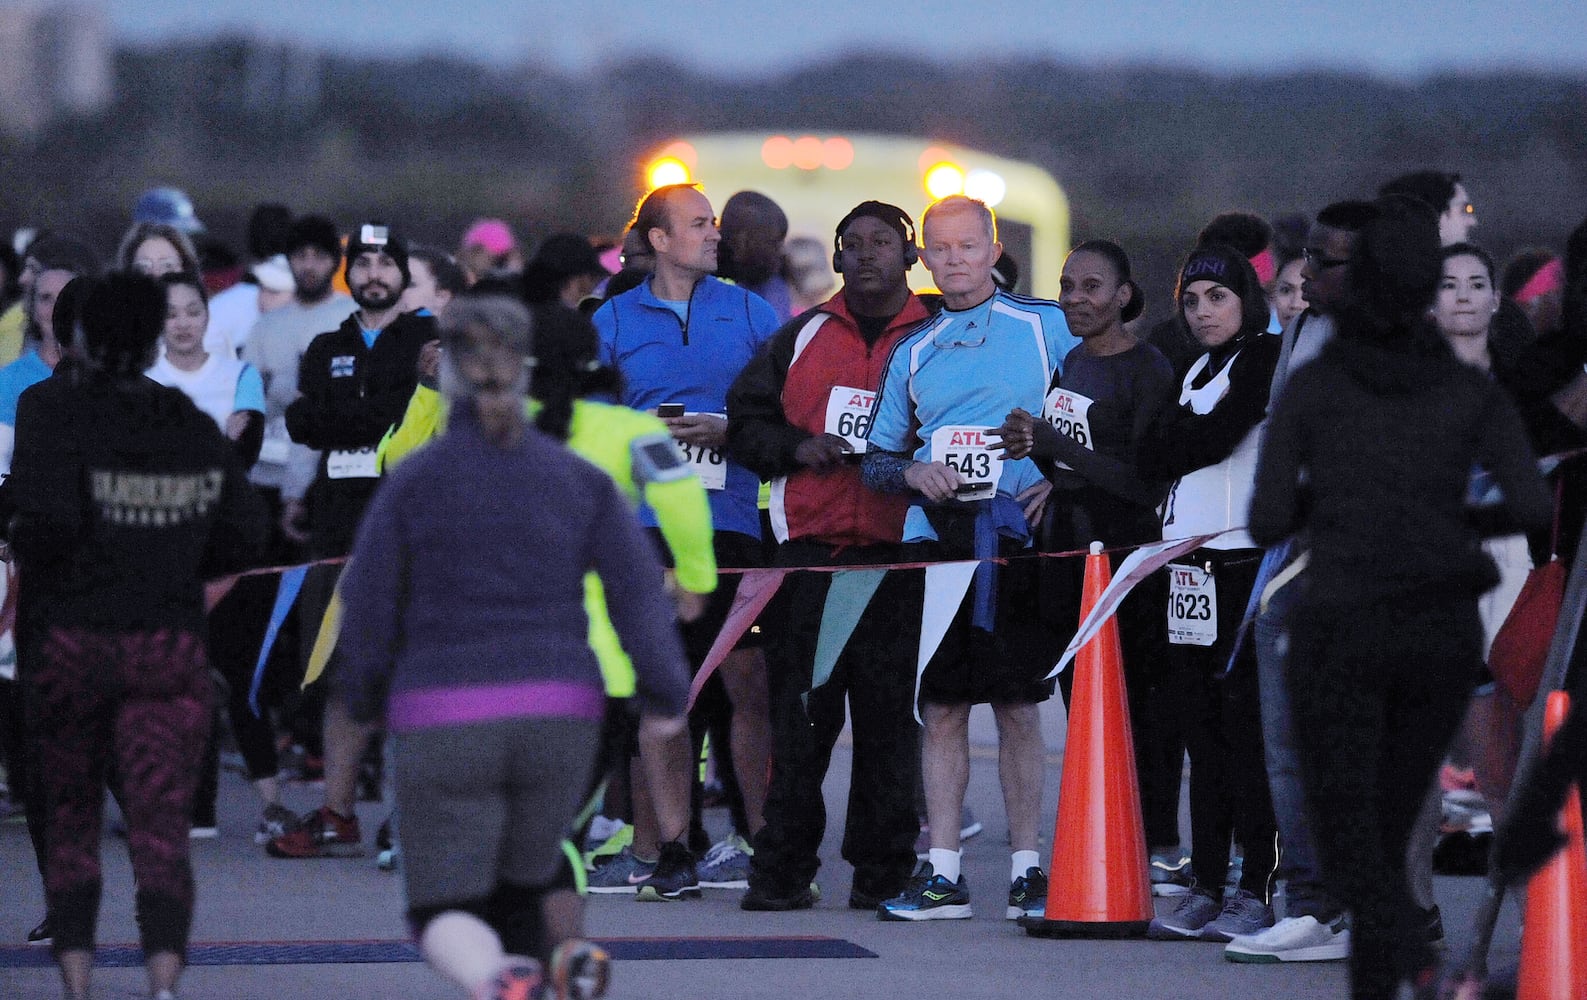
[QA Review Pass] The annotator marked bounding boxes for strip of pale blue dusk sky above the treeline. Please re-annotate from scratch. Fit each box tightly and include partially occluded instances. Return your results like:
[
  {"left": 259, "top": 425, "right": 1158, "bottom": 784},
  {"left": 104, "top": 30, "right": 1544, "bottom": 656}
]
[{"left": 108, "top": 0, "right": 1587, "bottom": 78}]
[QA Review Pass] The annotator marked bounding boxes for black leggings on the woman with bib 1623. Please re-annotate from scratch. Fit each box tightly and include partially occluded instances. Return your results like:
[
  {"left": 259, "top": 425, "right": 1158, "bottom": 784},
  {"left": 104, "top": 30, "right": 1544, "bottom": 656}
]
[{"left": 1168, "top": 549, "right": 1278, "bottom": 902}]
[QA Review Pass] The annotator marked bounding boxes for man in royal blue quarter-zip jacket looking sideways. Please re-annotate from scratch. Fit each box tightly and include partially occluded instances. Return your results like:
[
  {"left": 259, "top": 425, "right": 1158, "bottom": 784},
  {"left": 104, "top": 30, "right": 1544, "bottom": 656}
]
[{"left": 592, "top": 184, "right": 778, "bottom": 898}]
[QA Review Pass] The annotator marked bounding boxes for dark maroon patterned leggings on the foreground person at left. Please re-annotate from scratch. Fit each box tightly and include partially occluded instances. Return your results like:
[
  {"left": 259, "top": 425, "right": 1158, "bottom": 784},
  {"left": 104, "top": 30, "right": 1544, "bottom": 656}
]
[{"left": 32, "top": 627, "right": 211, "bottom": 956}]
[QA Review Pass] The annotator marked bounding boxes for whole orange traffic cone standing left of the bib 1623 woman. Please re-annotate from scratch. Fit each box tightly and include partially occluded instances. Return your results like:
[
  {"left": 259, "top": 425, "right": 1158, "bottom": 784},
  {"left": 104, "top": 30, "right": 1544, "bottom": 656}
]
[{"left": 1019, "top": 541, "right": 1154, "bottom": 938}]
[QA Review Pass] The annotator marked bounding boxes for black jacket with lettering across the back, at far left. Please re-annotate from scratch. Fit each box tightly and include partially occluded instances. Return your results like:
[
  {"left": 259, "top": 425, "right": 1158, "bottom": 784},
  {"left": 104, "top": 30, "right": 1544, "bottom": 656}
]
[{"left": 5, "top": 376, "right": 267, "bottom": 630}]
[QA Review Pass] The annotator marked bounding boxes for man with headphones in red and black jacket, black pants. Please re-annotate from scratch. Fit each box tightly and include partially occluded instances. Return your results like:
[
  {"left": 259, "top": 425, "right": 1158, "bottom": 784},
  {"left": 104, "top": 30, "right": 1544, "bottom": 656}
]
[{"left": 727, "top": 202, "right": 930, "bottom": 910}]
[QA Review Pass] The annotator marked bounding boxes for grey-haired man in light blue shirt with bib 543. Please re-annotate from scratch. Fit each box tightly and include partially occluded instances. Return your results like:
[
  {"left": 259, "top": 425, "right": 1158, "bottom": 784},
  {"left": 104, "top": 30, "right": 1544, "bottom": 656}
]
[{"left": 863, "top": 195, "right": 1079, "bottom": 921}]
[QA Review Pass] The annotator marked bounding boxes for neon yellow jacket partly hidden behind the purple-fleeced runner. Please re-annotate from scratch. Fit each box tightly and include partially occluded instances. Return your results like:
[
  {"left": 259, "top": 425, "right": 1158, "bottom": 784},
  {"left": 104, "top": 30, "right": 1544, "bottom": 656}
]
[{"left": 379, "top": 386, "right": 716, "bottom": 698}]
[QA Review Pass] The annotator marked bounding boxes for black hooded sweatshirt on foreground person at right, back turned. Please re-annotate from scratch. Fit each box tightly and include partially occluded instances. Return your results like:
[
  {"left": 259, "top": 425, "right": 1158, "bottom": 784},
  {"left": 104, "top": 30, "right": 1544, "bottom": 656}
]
[{"left": 1249, "top": 322, "right": 1550, "bottom": 605}]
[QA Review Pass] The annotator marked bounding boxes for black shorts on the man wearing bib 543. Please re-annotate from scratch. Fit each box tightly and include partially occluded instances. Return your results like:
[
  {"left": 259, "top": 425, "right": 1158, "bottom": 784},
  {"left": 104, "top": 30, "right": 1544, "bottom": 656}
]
[{"left": 905, "top": 541, "right": 1063, "bottom": 705}]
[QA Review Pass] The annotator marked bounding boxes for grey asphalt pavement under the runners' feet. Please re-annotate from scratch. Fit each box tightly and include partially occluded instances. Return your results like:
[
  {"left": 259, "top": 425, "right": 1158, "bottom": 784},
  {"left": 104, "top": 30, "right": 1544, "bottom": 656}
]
[{"left": 0, "top": 702, "right": 1519, "bottom": 1000}]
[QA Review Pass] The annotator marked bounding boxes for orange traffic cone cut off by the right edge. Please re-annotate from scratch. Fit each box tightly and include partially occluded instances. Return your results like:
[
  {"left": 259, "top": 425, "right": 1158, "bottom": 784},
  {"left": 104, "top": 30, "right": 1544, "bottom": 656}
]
[{"left": 1516, "top": 690, "right": 1587, "bottom": 1000}]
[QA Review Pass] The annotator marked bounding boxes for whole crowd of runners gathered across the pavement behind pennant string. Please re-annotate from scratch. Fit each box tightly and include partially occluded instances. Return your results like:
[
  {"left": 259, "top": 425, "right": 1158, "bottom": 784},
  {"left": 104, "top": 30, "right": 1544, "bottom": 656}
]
[{"left": 0, "top": 171, "right": 1587, "bottom": 998}]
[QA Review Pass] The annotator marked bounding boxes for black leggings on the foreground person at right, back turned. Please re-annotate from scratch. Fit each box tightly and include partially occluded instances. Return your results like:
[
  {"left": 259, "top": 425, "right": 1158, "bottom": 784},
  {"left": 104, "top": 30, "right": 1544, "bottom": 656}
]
[{"left": 1287, "top": 597, "right": 1482, "bottom": 998}]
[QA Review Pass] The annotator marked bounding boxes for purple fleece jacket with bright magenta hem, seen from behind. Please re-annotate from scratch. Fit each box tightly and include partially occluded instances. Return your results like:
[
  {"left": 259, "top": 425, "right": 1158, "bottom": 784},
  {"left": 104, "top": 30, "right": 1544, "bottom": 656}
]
[{"left": 335, "top": 406, "right": 689, "bottom": 732}]
